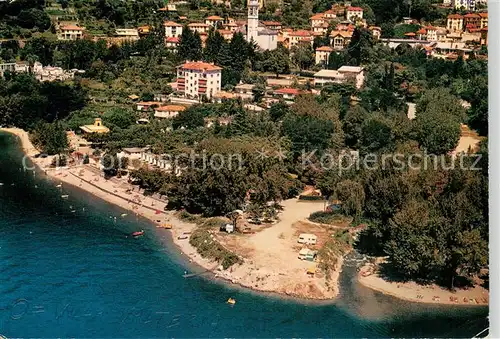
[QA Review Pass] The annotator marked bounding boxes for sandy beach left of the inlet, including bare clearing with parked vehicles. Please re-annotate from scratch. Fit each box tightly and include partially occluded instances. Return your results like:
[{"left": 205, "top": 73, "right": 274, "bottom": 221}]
[{"left": 0, "top": 128, "right": 342, "bottom": 300}]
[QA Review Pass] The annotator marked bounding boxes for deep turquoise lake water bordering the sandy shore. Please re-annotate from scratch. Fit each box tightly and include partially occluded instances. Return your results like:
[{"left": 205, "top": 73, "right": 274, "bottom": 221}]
[{"left": 0, "top": 134, "right": 487, "bottom": 338}]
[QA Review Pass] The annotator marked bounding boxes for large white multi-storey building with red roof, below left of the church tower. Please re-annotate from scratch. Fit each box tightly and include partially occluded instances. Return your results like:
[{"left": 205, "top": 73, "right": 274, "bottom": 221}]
[{"left": 177, "top": 61, "right": 222, "bottom": 99}]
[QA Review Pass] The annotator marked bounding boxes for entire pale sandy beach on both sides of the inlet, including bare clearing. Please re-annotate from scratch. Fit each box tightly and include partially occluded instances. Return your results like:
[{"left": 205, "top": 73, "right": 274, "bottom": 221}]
[{"left": 0, "top": 128, "right": 488, "bottom": 305}]
